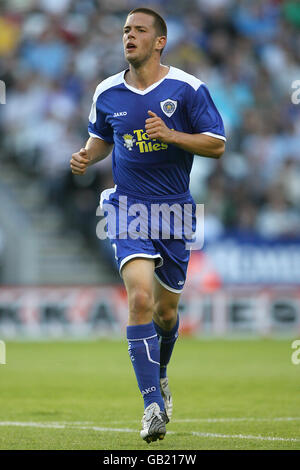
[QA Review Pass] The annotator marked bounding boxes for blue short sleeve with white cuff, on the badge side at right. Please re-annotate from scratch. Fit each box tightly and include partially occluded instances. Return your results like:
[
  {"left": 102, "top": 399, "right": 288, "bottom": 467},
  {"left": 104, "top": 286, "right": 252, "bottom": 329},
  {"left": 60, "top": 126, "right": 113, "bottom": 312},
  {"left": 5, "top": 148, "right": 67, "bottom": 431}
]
[{"left": 191, "top": 84, "right": 226, "bottom": 141}]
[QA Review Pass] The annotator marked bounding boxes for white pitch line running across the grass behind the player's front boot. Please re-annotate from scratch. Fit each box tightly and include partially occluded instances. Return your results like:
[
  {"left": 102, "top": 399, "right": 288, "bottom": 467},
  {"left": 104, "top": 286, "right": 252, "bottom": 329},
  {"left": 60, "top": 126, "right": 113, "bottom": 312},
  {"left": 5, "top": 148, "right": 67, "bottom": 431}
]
[{"left": 0, "top": 421, "right": 300, "bottom": 442}]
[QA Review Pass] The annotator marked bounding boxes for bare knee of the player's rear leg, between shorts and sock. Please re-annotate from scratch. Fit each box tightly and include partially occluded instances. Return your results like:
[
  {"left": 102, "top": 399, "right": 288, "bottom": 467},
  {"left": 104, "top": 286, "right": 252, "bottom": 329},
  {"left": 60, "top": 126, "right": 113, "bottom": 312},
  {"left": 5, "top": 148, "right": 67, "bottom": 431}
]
[{"left": 153, "top": 279, "right": 181, "bottom": 328}]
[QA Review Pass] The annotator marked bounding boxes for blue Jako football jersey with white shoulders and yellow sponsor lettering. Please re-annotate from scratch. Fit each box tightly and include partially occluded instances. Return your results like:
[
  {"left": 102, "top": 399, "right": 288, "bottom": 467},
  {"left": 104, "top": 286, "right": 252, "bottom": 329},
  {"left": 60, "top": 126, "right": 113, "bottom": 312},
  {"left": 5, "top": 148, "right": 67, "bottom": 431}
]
[{"left": 88, "top": 67, "right": 226, "bottom": 197}]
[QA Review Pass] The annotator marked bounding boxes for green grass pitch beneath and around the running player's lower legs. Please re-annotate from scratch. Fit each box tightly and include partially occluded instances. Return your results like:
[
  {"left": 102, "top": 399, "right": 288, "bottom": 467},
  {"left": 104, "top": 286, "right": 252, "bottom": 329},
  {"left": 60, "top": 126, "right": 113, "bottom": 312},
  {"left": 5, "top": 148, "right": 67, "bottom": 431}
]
[{"left": 0, "top": 338, "right": 300, "bottom": 450}]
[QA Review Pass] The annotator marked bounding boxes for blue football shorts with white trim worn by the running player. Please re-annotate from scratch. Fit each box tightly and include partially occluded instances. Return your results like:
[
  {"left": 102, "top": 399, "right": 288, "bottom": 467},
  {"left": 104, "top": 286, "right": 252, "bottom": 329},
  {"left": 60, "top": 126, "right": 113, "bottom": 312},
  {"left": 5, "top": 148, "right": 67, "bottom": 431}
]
[{"left": 100, "top": 186, "right": 196, "bottom": 293}]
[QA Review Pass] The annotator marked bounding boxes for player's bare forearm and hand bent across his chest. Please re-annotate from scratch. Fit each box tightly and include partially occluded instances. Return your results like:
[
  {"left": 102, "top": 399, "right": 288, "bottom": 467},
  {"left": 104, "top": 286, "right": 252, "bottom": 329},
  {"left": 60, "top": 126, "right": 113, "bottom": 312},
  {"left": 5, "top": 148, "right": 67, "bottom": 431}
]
[{"left": 146, "top": 111, "right": 225, "bottom": 158}]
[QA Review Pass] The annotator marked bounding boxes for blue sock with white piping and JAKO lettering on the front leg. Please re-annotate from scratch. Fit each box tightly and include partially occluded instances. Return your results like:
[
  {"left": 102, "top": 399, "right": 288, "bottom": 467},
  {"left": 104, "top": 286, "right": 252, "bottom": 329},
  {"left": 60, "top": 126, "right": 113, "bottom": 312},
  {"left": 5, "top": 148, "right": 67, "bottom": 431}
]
[{"left": 127, "top": 322, "right": 165, "bottom": 410}]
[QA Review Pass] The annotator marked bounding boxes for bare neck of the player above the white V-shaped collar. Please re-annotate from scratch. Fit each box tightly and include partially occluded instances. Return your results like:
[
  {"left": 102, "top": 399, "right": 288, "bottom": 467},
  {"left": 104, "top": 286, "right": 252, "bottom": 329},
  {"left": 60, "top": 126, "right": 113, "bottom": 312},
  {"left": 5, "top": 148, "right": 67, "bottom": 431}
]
[{"left": 125, "top": 63, "right": 169, "bottom": 90}]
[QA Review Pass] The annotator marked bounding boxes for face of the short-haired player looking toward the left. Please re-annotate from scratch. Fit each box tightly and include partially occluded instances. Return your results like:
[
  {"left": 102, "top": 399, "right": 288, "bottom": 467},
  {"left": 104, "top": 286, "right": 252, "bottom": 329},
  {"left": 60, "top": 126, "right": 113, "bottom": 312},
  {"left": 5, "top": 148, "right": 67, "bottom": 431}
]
[{"left": 123, "top": 13, "right": 159, "bottom": 66}]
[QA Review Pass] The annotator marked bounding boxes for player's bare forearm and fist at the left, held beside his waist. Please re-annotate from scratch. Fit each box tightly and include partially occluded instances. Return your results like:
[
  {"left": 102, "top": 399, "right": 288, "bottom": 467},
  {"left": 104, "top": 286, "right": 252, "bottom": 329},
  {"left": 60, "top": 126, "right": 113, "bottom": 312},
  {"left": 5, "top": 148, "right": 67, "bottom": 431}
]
[{"left": 70, "top": 137, "right": 113, "bottom": 175}]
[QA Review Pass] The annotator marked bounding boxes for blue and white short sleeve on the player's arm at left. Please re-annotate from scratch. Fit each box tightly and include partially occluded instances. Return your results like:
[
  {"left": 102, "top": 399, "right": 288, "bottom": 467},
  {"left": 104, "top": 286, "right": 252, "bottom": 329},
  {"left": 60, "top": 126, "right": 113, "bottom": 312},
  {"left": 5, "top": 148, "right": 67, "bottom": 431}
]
[{"left": 88, "top": 90, "right": 114, "bottom": 144}]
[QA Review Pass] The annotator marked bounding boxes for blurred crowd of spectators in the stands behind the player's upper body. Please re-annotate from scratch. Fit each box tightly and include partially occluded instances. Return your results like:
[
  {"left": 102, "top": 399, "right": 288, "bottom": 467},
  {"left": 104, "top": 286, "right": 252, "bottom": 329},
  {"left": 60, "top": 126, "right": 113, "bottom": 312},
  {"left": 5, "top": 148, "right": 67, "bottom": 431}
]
[{"left": 0, "top": 0, "right": 300, "bottom": 253}]
